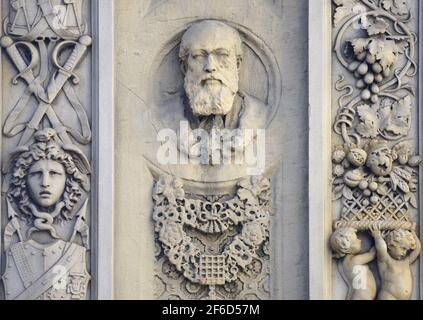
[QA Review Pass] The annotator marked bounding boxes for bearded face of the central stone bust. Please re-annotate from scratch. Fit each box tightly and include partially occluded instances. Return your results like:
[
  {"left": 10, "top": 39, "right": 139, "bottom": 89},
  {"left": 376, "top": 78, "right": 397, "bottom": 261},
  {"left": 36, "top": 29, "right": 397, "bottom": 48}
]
[{"left": 184, "top": 24, "right": 239, "bottom": 116}]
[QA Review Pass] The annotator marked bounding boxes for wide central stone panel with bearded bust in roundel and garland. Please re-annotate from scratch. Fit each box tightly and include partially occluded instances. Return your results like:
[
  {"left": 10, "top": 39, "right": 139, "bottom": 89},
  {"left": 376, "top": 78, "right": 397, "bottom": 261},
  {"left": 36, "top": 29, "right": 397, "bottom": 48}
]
[{"left": 115, "top": 0, "right": 308, "bottom": 299}]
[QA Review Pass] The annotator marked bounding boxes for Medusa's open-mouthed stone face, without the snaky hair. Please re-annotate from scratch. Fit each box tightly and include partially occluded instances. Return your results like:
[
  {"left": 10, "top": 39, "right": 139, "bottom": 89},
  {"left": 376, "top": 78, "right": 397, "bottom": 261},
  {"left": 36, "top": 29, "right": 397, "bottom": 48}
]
[{"left": 27, "top": 160, "right": 66, "bottom": 208}]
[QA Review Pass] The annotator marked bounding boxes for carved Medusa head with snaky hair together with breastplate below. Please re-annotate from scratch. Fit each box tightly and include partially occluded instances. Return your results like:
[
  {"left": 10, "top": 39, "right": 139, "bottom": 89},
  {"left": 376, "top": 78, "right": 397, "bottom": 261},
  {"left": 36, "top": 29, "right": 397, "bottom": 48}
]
[{"left": 3, "top": 129, "right": 90, "bottom": 300}]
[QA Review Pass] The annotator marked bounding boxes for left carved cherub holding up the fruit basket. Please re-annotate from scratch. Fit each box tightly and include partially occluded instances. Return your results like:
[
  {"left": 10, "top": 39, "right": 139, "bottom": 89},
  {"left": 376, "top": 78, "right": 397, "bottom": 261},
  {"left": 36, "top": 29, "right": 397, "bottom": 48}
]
[{"left": 330, "top": 228, "right": 376, "bottom": 300}]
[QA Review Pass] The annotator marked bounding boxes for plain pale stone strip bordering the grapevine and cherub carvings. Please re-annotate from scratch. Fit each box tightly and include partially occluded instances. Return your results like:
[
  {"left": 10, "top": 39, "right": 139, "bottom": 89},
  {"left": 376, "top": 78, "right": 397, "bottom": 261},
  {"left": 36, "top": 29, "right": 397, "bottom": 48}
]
[{"left": 309, "top": 0, "right": 332, "bottom": 300}]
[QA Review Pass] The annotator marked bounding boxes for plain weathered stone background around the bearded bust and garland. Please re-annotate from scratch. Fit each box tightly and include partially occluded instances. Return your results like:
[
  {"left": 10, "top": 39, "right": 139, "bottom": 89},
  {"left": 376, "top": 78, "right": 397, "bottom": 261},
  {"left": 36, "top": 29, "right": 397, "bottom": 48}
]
[{"left": 115, "top": 1, "right": 307, "bottom": 299}]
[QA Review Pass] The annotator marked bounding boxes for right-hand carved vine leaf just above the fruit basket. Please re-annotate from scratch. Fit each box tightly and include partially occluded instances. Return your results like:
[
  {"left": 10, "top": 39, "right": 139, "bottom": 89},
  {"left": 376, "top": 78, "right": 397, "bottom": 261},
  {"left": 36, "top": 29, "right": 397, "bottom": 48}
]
[{"left": 380, "top": 96, "right": 412, "bottom": 136}]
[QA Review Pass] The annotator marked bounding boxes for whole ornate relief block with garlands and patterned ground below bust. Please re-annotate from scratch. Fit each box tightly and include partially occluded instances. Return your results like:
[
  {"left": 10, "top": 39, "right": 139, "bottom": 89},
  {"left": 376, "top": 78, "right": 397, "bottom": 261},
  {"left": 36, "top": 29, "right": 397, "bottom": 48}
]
[{"left": 153, "top": 176, "right": 271, "bottom": 299}]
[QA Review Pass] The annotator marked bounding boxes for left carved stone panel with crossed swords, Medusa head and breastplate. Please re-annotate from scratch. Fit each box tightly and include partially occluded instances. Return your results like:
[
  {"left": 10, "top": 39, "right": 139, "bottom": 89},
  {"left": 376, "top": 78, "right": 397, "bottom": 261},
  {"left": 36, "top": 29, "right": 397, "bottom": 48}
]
[{"left": 0, "top": 0, "right": 92, "bottom": 300}]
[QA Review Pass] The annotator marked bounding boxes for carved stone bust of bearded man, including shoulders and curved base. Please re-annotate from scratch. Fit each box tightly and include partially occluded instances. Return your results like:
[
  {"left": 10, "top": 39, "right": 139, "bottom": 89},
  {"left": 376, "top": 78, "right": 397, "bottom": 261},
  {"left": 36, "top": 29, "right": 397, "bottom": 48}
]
[{"left": 145, "top": 20, "right": 269, "bottom": 189}]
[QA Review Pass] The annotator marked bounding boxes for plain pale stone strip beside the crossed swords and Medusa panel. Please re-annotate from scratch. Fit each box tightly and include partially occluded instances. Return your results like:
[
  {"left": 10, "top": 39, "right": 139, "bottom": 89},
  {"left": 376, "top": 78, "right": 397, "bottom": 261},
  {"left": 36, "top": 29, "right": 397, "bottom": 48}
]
[{"left": 93, "top": 0, "right": 114, "bottom": 300}]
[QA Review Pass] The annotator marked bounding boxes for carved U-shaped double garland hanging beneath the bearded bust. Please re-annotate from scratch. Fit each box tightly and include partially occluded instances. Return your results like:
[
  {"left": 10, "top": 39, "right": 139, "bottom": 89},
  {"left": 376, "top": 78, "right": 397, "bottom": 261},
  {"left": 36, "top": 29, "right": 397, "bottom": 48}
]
[{"left": 153, "top": 176, "right": 270, "bottom": 298}]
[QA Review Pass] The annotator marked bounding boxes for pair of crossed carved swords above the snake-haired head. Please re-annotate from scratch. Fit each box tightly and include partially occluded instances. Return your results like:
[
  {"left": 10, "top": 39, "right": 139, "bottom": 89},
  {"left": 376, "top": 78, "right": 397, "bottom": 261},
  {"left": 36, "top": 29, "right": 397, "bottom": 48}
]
[{"left": 0, "top": 35, "right": 92, "bottom": 146}]
